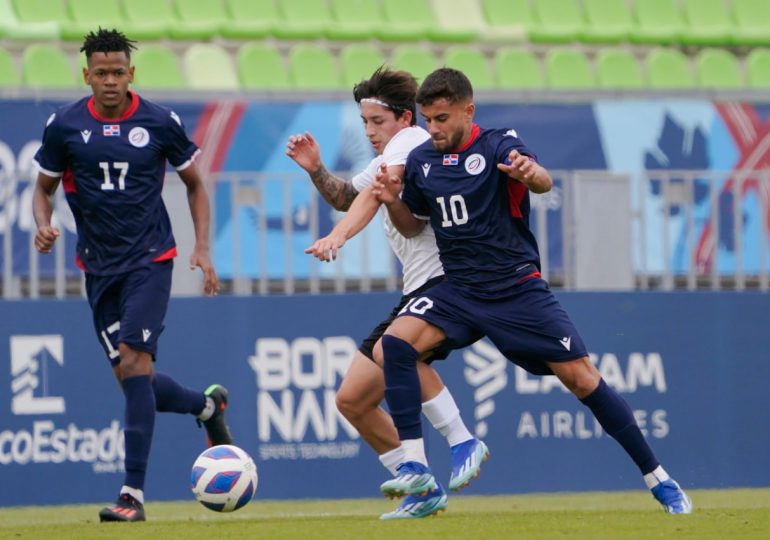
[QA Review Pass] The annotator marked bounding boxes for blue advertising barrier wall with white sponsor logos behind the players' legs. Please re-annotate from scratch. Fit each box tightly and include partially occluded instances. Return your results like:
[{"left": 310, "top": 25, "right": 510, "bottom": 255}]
[{"left": 0, "top": 293, "right": 770, "bottom": 505}]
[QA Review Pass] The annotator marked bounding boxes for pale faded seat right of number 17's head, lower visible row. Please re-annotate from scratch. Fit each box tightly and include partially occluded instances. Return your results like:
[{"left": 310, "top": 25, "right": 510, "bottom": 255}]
[{"left": 183, "top": 43, "right": 239, "bottom": 90}]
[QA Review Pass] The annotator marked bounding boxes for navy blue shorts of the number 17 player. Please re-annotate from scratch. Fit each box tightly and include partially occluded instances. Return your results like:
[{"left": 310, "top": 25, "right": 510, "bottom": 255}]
[{"left": 86, "top": 260, "right": 174, "bottom": 366}]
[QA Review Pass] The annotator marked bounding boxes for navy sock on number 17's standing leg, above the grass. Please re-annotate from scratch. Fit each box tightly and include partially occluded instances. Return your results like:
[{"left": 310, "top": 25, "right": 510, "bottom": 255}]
[{"left": 123, "top": 375, "right": 155, "bottom": 490}]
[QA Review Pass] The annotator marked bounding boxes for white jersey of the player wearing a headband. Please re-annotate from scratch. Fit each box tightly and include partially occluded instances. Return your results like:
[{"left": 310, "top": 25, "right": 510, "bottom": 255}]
[{"left": 352, "top": 126, "right": 444, "bottom": 294}]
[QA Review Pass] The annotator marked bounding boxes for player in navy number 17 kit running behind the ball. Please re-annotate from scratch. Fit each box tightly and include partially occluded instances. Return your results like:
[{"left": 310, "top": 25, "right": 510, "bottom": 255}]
[{"left": 32, "top": 28, "right": 232, "bottom": 521}]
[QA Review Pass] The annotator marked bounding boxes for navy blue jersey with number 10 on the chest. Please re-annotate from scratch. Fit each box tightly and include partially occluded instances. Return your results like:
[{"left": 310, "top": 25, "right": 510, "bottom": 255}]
[{"left": 402, "top": 124, "right": 540, "bottom": 297}]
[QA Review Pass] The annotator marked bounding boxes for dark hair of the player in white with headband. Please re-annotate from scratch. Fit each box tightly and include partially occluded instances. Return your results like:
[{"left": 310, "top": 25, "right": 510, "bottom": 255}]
[{"left": 353, "top": 66, "right": 417, "bottom": 126}]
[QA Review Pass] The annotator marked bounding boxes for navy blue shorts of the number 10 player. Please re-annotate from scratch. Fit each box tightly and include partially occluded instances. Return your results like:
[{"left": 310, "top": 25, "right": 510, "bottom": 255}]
[{"left": 399, "top": 277, "right": 588, "bottom": 375}]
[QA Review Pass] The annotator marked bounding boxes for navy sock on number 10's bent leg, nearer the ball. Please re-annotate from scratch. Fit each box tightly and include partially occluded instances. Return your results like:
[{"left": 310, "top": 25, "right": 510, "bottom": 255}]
[{"left": 382, "top": 335, "right": 422, "bottom": 441}]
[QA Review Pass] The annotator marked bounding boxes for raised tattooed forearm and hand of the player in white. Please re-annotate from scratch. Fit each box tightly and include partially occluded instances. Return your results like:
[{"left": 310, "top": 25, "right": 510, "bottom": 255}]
[{"left": 286, "top": 131, "right": 358, "bottom": 212}]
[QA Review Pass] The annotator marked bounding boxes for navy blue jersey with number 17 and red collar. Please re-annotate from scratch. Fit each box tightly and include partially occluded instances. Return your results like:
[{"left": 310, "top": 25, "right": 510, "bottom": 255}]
[{"left": 35, "top": 93, "right": 198, "bottom": 275}]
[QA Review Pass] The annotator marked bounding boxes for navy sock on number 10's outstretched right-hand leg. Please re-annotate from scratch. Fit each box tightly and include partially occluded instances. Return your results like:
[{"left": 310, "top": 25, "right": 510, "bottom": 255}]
[{"left": 580, "top": 379, "right": 660, "bottom": 474}]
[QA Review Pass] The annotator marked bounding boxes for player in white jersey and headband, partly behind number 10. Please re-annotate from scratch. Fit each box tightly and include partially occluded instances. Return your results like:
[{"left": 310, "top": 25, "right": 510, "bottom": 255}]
[{"left": 287, "top": 68, "right": 489, "bottom": 519}]
